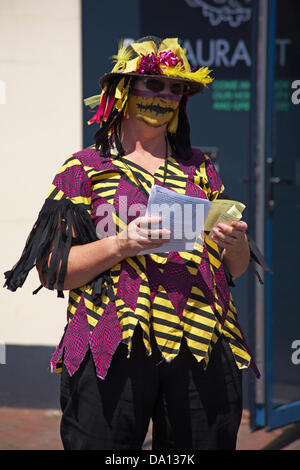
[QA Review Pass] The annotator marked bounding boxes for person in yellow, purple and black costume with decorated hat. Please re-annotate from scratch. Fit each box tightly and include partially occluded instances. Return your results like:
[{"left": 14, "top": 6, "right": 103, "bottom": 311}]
[{"left": 5, "top": 37, "right": 266, "bottom": 450}]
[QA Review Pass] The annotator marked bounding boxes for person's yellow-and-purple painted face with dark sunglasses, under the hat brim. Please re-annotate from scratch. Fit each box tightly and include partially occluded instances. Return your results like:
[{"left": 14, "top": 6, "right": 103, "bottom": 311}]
[{"left": 128, "top": 78, "right": 183, "bottom": 127}]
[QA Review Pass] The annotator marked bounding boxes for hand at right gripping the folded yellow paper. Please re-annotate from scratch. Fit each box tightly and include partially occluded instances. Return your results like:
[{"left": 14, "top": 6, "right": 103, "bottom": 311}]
[{"left": 211, "top": 220, "right": 248, "bottom": 254}]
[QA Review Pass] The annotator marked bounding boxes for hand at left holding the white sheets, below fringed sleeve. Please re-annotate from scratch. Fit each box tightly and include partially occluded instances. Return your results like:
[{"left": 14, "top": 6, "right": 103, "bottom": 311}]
[{"left": 116, "top": 216, "right": 171, "bottom": 258}]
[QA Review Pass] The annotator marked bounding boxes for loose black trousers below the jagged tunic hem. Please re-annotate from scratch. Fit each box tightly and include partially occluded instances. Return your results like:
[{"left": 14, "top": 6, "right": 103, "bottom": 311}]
[{"left": 60, "top": 326, "right": 242, "bottom": 451}]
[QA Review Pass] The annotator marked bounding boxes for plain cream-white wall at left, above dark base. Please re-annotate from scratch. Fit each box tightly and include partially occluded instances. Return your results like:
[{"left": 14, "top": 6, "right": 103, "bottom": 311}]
[{"left": 0, "top": 0, "right": 82, "bottom": 345}]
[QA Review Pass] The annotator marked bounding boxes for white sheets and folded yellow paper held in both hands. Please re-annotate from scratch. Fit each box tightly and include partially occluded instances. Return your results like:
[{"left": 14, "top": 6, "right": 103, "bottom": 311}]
[{"left": 139, "top": 185, "right": 245, "bottom": 255}]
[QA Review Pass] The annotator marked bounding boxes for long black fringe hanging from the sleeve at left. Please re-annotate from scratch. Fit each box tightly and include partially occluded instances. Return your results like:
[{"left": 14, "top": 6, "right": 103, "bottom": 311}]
[{"left": 3, "top": 199, "right": 113, "bottom": 305}]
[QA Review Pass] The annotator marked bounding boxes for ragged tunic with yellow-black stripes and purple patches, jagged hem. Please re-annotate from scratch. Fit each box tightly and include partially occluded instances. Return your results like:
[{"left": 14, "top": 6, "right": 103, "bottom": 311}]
[{"left": 3, "top": 146, "right": 259, "bottom": 379}]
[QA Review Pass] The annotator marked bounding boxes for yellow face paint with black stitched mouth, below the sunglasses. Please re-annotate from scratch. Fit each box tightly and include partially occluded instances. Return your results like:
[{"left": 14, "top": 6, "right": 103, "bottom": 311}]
[{"left": 128, "top": 90, "right": 180, "bottom": 127}]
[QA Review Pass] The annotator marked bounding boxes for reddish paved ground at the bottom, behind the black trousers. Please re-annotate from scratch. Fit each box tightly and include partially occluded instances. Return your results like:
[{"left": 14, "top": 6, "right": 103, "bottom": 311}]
[{"left": 0, "top": 408, "right": 300, "bottom": 450}]
